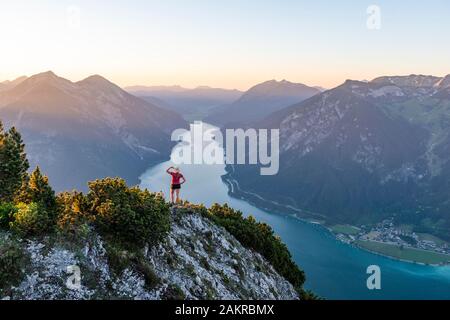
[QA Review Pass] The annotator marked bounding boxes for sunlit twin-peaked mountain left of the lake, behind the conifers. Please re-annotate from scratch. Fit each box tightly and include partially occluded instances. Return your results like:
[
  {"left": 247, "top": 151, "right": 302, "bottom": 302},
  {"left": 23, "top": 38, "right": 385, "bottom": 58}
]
[{"left": 0, "top": 71, "right": 186, "bottom": 191}]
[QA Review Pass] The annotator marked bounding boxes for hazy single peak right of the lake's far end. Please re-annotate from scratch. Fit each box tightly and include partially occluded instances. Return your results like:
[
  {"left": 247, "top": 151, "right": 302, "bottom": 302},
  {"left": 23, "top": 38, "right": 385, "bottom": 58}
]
[{"left": 205, "top": 80, "right": 321, "bottom": 128}]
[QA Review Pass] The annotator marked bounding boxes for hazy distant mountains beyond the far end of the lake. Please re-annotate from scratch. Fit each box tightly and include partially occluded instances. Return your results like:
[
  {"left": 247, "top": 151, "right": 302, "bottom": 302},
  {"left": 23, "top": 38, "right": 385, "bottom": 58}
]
[{"left": 125, "top": 80, "right": 324, "bottom": 127}]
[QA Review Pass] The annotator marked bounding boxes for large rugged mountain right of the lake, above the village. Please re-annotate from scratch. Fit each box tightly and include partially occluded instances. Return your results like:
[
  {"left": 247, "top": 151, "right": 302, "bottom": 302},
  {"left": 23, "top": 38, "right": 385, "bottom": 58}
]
[{"left": 226, "top": 75, "right": 450, "bottom": 239}]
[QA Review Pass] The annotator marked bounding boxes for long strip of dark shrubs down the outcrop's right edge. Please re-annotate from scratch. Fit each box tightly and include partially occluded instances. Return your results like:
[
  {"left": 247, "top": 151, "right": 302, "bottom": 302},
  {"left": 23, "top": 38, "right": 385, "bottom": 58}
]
[{"left": 202, "top": 204, "right": 305, "bottom": 295}]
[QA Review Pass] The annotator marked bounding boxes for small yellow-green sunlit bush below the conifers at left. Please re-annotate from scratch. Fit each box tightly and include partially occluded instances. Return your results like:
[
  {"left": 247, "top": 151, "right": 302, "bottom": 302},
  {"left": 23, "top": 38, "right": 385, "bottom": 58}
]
[{"left": 10, "top": 202, "right": 51, "bottom": 236}]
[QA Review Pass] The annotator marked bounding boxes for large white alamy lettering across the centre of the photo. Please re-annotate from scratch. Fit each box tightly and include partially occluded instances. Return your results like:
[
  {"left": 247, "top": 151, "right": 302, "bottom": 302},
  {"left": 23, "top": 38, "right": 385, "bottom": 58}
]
[{"left": 172, "top": 121, "right": 280, "bottom": 175}]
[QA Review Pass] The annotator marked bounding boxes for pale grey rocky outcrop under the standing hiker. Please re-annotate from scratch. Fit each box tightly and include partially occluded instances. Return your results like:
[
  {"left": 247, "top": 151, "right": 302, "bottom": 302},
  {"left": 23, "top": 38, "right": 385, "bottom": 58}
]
[{"left": 0, "top": 209, "right": 298, "bottom": 299}]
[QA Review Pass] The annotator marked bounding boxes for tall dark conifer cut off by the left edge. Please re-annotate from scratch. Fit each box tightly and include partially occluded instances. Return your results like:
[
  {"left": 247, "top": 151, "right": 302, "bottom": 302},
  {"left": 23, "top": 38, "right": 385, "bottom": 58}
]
[{"left": 0, "top": 122, "right": 29, "bottom": 202}]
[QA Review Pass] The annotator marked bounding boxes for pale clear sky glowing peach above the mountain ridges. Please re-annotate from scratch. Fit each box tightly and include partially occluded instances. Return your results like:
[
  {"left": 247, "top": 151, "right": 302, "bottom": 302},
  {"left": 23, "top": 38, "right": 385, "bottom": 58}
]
[{"left": 0, "top": 0, "right": 450, "bottom": 89}]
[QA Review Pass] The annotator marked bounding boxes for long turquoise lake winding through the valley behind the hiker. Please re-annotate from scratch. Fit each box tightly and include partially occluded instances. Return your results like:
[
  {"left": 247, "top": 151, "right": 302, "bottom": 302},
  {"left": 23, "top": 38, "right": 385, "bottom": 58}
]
[{"left": 141, "top": 122, "right": 450, "bottom": 299}]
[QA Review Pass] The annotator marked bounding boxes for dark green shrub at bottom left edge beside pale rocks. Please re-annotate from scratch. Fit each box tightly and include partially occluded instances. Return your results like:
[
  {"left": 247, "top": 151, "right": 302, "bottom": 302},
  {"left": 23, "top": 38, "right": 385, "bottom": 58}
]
[{"left": 0, "top": 239, "right": 27, "bottom": 293}]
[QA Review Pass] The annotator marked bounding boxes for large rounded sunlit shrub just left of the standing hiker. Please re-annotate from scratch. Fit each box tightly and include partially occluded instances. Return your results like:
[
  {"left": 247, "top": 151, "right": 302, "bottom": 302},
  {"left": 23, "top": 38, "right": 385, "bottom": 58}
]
[{"left": 88, "top": 178, "right": 170, "bottom": 245}]
